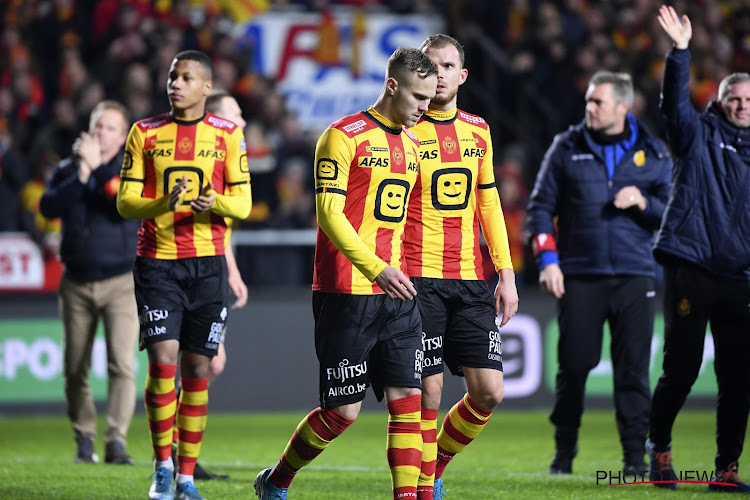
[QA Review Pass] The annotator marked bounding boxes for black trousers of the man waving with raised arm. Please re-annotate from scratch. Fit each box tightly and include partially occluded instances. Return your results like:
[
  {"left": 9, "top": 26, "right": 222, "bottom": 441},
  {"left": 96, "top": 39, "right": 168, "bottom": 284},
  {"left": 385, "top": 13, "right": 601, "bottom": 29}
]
[{"left": 650, "top": 262, "right": 750, "bottom": 470}]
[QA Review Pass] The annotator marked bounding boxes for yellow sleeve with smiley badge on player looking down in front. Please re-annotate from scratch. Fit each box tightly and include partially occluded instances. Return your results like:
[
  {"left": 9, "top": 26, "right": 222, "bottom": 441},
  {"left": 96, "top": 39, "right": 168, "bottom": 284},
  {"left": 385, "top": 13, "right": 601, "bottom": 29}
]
[{"left": 315, "top": 128, "right": 388, "bottom": 281}]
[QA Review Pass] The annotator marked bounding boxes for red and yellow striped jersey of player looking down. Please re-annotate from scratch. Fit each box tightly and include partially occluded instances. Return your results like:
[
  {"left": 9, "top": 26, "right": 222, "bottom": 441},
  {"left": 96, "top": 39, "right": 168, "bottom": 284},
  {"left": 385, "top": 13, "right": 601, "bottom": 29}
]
[{"left": 313, "top": 107, "right": 419, "bottom": 295}]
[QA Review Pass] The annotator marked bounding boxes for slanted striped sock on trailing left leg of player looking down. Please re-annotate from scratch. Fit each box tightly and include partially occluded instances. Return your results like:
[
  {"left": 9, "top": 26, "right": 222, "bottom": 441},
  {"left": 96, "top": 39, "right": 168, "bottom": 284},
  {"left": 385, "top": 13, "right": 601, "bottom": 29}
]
[{"left": 268, "top": 408, "right": 354, "bottom": 488}]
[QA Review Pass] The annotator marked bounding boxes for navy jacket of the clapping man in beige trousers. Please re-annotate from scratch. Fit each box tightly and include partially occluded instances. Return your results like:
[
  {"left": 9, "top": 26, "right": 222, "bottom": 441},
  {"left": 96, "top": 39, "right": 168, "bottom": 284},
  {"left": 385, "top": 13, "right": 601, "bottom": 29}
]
[{"left": 39, "top": 150, "right": 141, "bottom": 281}]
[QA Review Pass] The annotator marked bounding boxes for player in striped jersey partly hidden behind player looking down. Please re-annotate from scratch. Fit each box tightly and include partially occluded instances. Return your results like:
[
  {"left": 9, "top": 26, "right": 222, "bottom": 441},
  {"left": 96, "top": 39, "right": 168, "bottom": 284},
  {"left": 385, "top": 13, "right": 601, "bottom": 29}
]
[{"left": 404, "top": 35, "right": 518, "bottom": 500}]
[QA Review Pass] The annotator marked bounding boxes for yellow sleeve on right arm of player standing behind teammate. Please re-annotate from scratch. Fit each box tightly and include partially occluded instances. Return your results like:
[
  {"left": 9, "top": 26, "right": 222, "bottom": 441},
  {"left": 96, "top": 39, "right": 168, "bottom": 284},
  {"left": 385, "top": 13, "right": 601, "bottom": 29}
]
[{"left": 477, "top": 130, "right": 513, "bottom": 272}]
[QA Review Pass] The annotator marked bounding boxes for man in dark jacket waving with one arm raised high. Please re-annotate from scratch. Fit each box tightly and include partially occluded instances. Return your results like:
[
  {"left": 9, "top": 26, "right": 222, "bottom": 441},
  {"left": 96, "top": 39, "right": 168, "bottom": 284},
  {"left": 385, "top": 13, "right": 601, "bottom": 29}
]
[{"left": 648, "top": 6, "right": 750, "bottom": 492}]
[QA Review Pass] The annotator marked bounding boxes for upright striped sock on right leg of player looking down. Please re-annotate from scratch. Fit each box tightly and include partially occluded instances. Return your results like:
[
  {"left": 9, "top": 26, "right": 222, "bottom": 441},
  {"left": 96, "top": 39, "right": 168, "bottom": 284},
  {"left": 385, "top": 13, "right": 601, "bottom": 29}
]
[{"left": 386, "top": 394, "right": 422, "bottom": 499}]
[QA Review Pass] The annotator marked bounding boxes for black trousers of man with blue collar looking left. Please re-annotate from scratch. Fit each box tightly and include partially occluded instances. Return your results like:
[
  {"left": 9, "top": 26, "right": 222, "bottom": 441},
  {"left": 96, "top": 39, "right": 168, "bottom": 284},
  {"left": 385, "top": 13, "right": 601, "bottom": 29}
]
[{"left": 550, "top": 276, "right": 655, "bottom": 462}]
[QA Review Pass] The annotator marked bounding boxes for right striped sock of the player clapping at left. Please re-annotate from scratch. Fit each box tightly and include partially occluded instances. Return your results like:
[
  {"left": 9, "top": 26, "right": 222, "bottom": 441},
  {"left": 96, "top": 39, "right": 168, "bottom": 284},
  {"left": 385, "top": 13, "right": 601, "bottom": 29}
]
[{"left": 177, "top": 377, "right": 208, "bottom": 476}]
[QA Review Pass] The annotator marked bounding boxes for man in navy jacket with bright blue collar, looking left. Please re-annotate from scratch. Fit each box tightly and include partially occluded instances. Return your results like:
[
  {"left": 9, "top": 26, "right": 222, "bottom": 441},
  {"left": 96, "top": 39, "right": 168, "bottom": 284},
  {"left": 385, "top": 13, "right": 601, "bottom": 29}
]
[{"left": 527, "top": 71, "right": 672, "bottom": 474}]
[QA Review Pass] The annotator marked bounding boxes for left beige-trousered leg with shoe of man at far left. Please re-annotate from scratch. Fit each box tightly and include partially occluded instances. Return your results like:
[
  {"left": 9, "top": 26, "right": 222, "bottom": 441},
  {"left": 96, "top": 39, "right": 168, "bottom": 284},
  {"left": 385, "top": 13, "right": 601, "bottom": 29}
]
[{"left": 58, "top": 276, "right": 99, "bottom": 462}]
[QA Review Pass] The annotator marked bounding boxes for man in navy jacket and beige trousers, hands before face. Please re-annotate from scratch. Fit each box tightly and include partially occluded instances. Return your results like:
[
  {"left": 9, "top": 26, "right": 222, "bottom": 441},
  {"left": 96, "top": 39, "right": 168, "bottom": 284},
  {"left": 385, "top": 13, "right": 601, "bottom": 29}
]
[{"left": 40, "top": 101, "right": 140, "bottom": 464}]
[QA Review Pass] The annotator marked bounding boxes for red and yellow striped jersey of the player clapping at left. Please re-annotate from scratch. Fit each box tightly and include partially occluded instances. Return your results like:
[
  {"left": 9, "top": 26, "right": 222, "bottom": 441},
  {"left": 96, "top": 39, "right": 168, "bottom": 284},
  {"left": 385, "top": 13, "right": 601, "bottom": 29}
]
[{"left": 117, "top": 113, "right": 252, "bottom": 259}]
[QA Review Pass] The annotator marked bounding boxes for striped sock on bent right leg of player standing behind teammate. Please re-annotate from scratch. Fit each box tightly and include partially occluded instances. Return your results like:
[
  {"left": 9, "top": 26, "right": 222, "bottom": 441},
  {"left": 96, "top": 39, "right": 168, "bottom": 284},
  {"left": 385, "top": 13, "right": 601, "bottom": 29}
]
[{"left": 435, "top": 394, "right": 492, "bottom": 478}]
